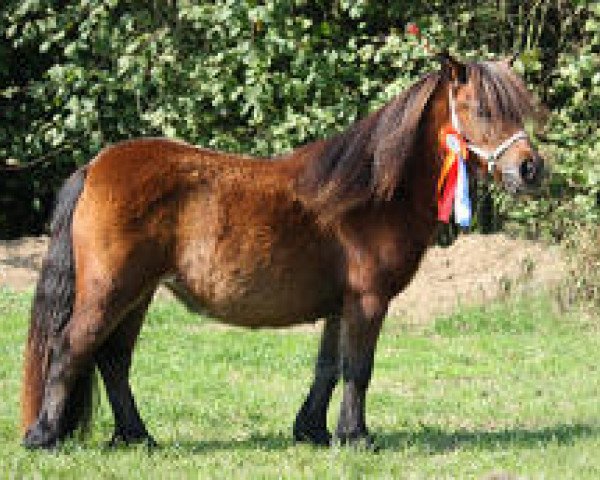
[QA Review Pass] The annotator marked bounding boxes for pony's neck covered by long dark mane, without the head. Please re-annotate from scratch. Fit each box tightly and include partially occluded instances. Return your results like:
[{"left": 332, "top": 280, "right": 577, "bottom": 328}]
[{"left": 287, "top": 74, "right": 449, "bottom": 230}]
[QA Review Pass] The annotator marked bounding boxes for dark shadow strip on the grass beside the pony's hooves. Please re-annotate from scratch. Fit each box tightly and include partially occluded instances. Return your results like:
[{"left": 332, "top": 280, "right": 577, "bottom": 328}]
[{"left": 159, "top": 424, "right": 600, "bottom": 454}]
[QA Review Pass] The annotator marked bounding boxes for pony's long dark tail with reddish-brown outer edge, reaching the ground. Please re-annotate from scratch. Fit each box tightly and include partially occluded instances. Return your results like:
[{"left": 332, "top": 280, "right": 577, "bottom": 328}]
[{"left": 22, "top": 167, "right": 94, "bottom": 437}]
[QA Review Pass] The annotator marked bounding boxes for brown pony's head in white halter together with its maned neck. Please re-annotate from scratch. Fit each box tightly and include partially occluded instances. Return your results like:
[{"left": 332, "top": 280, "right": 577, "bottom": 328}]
[{"left": 294, "top": 50, "right": 543, "bottom": 218}]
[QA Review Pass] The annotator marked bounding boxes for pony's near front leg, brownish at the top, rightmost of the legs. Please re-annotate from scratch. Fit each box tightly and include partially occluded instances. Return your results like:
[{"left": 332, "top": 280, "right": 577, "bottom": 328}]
[{"left": 336, "top": 293, "right": 388, "bottom": 446}]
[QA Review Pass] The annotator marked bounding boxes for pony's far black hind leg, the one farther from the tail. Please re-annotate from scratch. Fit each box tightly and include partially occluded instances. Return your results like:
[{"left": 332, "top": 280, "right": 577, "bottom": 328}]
[{"left": 94, "top": 295, "right": 156, "bottom": 446}]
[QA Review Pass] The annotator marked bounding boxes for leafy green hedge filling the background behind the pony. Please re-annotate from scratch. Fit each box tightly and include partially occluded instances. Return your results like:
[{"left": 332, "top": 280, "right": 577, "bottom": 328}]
[{"left": 0, "top": 0, "right": 600, "bottom": 236}]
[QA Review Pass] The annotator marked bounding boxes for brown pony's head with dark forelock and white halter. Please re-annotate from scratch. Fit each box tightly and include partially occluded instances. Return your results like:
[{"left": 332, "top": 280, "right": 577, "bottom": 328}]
[{"left": 441, "top": 53, "right": 544, "bottom": 193}]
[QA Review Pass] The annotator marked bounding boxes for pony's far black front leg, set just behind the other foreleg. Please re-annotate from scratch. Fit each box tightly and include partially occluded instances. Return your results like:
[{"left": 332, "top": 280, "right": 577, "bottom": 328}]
[{"left": 294, "top": 317, "right": 340, "bottom": 445}]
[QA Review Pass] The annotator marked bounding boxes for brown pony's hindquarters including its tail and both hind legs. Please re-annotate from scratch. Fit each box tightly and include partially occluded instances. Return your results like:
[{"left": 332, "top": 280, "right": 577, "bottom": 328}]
[{"left": 22, "top": 142, "right": 179, "bottom": 448}]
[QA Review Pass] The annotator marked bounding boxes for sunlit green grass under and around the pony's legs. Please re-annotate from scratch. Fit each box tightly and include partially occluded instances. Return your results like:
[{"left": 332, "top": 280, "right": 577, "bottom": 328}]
[{"left": 0, "top": 291, "right": 600, "bottom": 479}]
